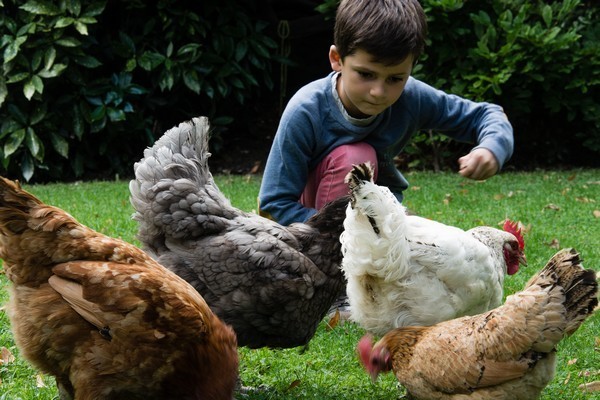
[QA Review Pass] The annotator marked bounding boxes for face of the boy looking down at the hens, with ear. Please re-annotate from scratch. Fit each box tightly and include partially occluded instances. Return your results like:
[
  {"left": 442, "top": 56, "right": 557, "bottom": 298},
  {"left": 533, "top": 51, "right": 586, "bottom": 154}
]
[{"left": 329, "top": 46, "right": 413, "bottom": 118}]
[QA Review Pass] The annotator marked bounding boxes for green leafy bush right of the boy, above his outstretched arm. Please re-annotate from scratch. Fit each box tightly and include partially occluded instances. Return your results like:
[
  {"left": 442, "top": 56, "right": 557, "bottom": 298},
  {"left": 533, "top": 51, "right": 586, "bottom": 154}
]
[{"left": 417, "top": 0, "right": 600, "bottom": 166}]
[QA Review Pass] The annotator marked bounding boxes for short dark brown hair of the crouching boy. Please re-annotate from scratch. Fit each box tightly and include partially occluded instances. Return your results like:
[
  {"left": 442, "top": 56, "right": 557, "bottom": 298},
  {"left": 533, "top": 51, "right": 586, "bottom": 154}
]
[{"left": 333, "top": 0, "right": 427, "bottom": 64}]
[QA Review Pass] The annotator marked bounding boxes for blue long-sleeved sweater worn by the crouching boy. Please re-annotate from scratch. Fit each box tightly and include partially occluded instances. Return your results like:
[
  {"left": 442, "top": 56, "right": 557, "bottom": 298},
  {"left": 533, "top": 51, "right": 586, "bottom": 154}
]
[{"left": 259, "top": 72, "right": 513, "bottom": 225}]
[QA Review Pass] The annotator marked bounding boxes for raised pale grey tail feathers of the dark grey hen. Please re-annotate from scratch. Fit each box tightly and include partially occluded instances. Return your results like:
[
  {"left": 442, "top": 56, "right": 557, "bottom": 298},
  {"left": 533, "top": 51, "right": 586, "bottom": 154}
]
[{"left": 129, "top": 117, "right": 234, "bottom": 251}]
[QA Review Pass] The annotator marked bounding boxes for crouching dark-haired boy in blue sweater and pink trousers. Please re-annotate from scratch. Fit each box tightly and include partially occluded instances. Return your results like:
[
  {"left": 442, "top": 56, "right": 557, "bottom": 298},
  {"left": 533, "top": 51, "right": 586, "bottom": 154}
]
[{"left": 259, "top": 0, "right": 513, "bottom": 225}]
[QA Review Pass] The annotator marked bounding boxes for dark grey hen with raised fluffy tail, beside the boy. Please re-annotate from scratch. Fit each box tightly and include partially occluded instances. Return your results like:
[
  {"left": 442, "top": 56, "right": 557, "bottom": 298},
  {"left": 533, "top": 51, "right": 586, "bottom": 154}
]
[{"left": 129, "top": 117, "right": 349, "bottom": 348}]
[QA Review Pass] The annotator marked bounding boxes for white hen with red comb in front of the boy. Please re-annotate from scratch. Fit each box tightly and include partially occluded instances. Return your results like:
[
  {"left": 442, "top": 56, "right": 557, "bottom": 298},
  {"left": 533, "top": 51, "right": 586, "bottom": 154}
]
[{"left": 340, "top": 163, "right": 525, "bottom": 335}]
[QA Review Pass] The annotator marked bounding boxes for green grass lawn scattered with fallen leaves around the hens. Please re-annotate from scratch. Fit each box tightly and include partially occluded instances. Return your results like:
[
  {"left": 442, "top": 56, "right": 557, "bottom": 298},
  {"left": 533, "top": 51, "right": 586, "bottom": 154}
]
[{"left": 0, "top": 169, "right": 600, "bottom": 400}]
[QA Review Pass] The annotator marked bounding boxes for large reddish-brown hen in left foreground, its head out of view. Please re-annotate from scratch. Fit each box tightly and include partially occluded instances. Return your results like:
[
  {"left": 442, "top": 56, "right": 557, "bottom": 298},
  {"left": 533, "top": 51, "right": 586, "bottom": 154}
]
[{"left": 0, "top": 178, "right": 238, "bottom": 400}]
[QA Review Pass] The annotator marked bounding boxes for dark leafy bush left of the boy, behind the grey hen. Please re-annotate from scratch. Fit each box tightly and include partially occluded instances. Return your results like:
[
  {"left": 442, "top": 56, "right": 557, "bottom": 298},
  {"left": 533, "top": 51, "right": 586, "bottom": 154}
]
[{"left": 0, "top": 0, "right": 277, "bottom": 180}]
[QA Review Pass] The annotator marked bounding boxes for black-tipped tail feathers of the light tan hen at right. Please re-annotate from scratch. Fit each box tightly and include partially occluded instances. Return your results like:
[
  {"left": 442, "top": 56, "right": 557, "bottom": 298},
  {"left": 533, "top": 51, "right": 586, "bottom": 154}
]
[{"left": 527, "top": 249, "right": 598, "bottom": 335}]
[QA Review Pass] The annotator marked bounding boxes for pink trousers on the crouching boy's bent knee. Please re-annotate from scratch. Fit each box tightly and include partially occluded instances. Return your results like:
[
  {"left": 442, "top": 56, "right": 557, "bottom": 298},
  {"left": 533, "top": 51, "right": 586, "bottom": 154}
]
[{"left": 300, "top": 142, "right": 377, "bottom": 210}]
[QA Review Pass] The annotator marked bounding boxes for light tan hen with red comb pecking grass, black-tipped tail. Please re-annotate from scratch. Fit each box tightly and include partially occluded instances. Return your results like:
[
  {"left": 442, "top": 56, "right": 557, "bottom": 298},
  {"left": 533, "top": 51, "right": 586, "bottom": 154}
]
[{"left": 358, "top": 249, "right": 598, "bottom": 400}]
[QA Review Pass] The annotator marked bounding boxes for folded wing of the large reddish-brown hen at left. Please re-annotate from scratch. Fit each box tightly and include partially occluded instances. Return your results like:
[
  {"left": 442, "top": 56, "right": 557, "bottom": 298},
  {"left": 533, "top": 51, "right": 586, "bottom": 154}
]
[{"left": 50, "top": 261, "right": 212, "bottom": 344}]
